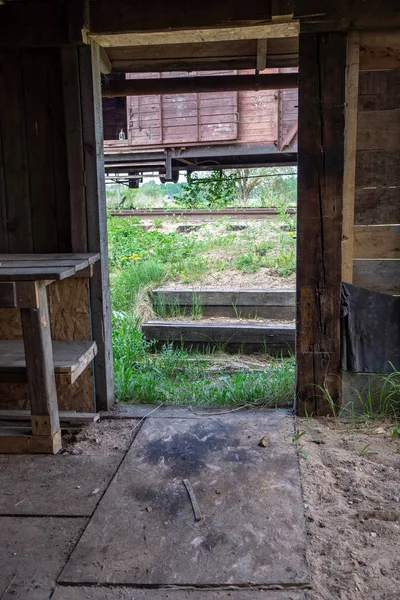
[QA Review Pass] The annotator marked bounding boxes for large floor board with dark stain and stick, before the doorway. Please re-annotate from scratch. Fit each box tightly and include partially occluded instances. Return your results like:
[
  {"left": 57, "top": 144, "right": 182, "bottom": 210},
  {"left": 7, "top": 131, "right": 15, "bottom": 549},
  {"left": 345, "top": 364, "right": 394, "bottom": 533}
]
[{"left": 59, "top": 411, "right": 309, "bottom": 587}]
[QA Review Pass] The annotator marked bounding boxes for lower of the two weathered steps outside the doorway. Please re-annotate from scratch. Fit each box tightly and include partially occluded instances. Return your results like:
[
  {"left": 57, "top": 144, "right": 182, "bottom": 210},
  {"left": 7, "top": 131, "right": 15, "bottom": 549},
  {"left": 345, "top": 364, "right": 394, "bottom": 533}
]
[{"left": 142, "top": 320, "right": 295, "bottom": 356}]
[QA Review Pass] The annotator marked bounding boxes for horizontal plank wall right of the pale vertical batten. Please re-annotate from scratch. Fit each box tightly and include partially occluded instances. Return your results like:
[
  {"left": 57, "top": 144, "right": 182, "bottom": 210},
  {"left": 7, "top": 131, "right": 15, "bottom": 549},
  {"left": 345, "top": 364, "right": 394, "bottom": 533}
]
[{"left": 353, "top": 32, "right": 400, "bottom": 294}]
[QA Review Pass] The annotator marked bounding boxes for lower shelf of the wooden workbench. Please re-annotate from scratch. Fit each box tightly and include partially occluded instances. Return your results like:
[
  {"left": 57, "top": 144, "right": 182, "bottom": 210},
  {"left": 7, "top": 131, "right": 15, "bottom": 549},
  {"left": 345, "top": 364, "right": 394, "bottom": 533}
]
[{"left": 0, "top": 340, "right": 97, "bottom": 383}]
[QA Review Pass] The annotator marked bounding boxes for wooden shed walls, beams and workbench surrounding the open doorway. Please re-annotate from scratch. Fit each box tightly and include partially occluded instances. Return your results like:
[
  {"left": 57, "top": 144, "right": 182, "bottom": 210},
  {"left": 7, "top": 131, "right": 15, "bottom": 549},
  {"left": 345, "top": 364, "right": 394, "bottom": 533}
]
[{"left": 0, "top": 0, "right": 400, "bottom": 451}]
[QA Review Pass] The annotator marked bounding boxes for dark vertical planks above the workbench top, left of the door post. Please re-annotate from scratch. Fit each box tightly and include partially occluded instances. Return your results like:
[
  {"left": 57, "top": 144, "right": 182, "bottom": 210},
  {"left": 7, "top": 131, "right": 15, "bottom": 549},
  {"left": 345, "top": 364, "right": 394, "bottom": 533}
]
[{"left": 0, "top": 50, "right": 71, "bottom": 252}]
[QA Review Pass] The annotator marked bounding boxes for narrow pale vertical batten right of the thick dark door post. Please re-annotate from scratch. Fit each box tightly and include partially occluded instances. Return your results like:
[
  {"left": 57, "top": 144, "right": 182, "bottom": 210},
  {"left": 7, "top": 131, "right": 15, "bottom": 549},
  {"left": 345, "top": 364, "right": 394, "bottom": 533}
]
[{"left": 342, "top": 31, "right": 360, "bottom": 283}]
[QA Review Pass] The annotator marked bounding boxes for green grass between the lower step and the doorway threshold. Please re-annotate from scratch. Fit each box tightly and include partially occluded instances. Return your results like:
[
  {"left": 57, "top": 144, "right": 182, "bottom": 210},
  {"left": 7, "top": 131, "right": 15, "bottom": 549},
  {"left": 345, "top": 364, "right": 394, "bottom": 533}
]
[{"left": 113, "top": 313, "right": 294, "bottom": 407}]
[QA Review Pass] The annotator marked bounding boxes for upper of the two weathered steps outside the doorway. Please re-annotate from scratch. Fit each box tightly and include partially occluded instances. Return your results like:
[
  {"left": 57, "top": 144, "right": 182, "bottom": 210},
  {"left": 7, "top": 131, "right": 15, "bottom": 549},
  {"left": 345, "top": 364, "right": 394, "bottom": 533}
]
[{"left": 153, "top": 287, "right": 296, "bottom": 321}]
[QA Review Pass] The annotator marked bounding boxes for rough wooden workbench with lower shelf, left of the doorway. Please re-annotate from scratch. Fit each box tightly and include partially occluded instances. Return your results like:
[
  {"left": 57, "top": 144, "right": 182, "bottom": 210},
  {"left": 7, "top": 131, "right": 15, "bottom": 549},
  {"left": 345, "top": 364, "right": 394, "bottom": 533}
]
[{"left": 0, "top": 254, "right": 100, "bottom": 453}]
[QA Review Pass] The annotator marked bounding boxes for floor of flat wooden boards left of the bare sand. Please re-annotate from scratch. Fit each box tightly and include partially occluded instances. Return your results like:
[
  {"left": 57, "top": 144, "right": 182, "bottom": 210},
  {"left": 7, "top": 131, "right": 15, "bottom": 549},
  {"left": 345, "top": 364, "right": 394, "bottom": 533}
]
[{"left": 0, "top": 407, "right": 309, "bottom": 600}]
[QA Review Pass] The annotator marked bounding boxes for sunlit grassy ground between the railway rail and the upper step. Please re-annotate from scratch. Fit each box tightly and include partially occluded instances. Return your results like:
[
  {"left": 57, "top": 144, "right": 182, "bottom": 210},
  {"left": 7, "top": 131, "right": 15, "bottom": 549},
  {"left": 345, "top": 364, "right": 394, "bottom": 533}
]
[{"left": 108, "top": 217, "right": 296, "bottom": 283}]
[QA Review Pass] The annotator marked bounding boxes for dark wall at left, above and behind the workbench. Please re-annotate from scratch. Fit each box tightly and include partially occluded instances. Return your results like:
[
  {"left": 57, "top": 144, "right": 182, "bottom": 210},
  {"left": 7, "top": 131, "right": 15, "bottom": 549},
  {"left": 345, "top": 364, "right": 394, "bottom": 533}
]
[{"left": 0, "top": 49, "right": 94, "bottom": 411}]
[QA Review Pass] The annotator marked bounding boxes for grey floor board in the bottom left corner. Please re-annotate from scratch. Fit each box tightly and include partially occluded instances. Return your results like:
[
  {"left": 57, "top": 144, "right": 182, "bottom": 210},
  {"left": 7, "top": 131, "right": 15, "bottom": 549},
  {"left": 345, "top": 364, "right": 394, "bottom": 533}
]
[{"left": 0, "top": 517, "right": 87, "bottom": 600}]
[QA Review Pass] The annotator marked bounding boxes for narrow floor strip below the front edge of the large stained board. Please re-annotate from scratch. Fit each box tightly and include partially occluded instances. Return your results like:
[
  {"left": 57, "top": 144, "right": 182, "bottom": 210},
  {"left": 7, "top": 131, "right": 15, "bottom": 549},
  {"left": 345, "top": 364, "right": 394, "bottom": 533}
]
[{"left": 52, "top": 586, "right": 305, "bottom": 600}]
